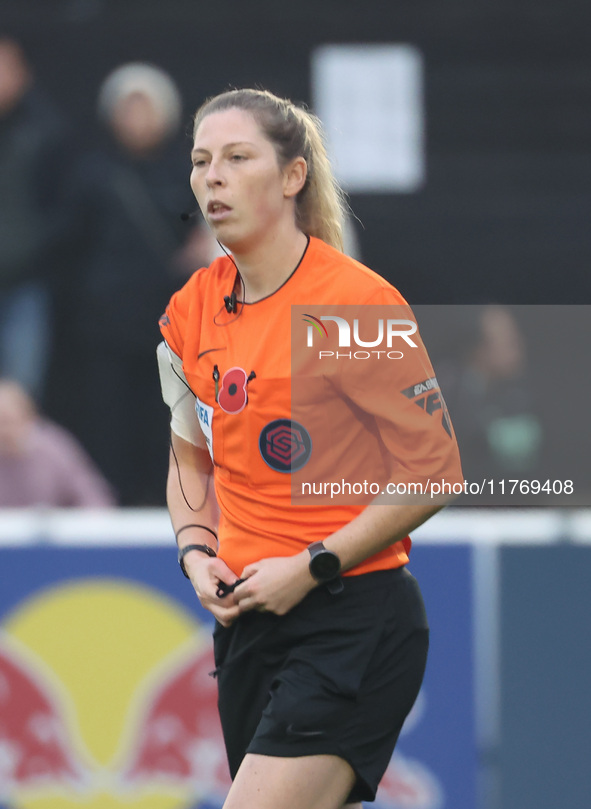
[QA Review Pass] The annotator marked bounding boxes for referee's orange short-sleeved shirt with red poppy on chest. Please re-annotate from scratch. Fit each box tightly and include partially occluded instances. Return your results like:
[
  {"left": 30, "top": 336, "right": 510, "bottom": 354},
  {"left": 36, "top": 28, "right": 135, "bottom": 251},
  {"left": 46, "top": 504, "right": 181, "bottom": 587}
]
[{"left": 160, "top": 237, "right": 461, "bottom": 576}]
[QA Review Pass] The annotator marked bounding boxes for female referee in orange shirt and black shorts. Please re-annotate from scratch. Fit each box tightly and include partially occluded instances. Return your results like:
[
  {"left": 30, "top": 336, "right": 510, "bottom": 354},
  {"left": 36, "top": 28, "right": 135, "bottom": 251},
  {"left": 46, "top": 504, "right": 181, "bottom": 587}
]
[{"left": 158, "top": 90, "right": 461, "bottom": 809}]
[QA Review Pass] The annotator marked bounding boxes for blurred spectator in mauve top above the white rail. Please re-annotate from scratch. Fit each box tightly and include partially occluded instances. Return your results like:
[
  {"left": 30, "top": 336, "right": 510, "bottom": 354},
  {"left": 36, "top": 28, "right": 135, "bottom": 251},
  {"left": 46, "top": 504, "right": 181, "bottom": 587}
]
[{"left": 0, "top": 380, "right": 115, "bottom": 508}]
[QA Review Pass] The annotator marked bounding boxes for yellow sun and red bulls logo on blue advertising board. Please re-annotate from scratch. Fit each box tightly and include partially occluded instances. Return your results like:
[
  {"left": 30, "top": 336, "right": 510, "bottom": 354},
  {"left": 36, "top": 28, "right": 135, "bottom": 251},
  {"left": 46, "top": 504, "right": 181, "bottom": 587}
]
[{"left": 0, "top": 579, "right": 443, "bottom": 809}]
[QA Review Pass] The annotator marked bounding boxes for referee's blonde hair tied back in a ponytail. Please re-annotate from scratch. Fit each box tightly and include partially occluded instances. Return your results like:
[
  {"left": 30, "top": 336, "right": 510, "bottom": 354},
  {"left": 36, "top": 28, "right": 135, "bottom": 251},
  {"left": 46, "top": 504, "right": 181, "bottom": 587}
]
[{"left": 194, "top": 89, "right": 348, "bottom": 251}]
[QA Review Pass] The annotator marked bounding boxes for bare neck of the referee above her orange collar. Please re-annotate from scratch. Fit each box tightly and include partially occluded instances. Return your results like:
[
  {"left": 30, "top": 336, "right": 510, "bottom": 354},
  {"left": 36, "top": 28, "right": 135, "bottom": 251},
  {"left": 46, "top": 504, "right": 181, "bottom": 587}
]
[{"left": 233, "top": 229, "right": 308, "bottom": 303}]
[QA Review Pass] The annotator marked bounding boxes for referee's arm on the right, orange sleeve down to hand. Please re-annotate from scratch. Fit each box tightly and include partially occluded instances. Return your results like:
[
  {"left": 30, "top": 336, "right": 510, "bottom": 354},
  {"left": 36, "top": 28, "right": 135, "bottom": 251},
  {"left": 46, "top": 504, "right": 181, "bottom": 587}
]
[{"left": 235, "top": 293, "right": 462, "bottom": 614}]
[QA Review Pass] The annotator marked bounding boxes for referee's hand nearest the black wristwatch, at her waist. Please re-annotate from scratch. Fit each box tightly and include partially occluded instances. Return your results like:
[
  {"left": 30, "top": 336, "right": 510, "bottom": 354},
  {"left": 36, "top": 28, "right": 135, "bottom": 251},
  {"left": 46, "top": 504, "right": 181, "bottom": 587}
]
[{"left": 232, "top": 550, "right": 317, "bottom": 615}]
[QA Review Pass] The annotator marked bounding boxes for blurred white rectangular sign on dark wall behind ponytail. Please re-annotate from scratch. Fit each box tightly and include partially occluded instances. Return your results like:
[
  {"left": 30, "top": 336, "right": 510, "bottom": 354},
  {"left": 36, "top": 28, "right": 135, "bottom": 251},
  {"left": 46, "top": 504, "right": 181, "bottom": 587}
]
[{"left": 312, "top": 44, "right": 426, "bottom": 193}]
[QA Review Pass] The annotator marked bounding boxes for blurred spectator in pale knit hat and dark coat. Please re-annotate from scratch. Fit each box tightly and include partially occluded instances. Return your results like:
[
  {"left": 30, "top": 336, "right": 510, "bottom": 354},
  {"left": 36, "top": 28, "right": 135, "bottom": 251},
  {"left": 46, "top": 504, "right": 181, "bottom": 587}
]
[{"left": 62, "top": 63, "right": 200, "bottom": 505}]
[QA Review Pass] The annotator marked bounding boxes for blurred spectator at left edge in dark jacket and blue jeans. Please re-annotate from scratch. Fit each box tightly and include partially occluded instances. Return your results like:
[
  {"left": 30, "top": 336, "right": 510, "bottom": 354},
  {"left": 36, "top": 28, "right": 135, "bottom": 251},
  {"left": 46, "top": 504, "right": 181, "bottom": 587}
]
[{"left": 0, "top": 35, "right": 68, "bottom": 398}]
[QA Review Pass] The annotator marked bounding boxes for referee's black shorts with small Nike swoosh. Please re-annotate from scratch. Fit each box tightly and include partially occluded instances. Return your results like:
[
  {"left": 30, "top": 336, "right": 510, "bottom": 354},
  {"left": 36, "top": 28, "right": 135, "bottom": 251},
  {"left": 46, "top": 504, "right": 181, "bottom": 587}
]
[{"left": 214, "top": 568, "right": 429, "bottom": 802}]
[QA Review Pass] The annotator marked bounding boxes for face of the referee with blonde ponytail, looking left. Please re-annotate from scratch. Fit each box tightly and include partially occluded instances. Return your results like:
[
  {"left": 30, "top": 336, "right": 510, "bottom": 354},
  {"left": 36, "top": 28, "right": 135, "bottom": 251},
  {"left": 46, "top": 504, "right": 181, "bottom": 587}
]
[{"left": 191, "top": 109, "right": 305, "bottom": 252}]
